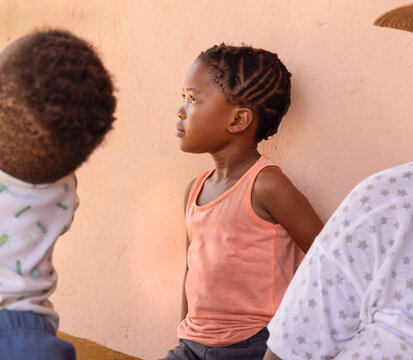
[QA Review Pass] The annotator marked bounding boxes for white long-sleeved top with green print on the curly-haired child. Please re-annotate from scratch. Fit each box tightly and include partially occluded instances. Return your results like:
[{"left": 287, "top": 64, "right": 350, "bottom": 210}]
[{"left": 0, "top": 171, "right": 78, "bottom": 327}]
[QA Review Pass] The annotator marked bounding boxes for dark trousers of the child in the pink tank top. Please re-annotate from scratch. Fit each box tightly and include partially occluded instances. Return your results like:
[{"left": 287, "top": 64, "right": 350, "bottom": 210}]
[{"left": 162, "top": 328, "right": 269, "bottom": 360}]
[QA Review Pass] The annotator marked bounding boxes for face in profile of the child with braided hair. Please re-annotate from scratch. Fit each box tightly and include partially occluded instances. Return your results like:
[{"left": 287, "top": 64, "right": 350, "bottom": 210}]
[{"left": 176, "top": 61, "right": 236, "bottom": 153}]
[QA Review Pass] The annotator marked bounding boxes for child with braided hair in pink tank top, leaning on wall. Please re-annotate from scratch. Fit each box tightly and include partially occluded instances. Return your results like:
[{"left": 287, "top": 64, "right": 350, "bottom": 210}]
[{"left": 164, "top": 44, "right": 323, "bottom": 360}]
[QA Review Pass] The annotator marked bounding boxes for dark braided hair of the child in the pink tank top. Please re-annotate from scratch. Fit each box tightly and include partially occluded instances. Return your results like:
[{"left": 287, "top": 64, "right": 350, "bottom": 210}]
[{"left": 197, "top": 43, "right": 291, "bottom": 143}]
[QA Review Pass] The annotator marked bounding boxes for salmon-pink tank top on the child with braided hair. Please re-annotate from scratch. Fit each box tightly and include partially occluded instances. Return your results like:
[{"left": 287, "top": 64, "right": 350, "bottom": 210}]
[{"left": 178, "top": 156, "right": 294, "bottom": 347}]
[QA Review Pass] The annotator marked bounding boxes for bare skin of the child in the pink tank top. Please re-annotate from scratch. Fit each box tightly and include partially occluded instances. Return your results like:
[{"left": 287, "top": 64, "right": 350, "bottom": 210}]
[{"left": 177, "top": 62, "right": 323, "bottom": 328}]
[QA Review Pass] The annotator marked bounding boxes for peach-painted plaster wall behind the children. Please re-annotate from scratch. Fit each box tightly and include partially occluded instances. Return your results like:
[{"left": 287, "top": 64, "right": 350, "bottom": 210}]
[{"left": 0, "top": 0, "right": 413, "bottom": 360}]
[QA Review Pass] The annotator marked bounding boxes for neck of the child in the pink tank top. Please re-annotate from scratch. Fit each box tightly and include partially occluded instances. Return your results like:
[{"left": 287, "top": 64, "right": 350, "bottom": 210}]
[{"left": 211, "top": 146, "right": 261, "bottom": 179}]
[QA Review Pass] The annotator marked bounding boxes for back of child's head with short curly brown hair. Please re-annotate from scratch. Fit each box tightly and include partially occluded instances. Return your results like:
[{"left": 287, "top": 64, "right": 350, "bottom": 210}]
[{"left": 0, "top": 30, "right": 116, "bottom": 183}]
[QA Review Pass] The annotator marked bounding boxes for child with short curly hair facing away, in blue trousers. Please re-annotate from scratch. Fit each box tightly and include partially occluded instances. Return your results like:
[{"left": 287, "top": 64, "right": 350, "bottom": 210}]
[{"left": 0, "top": 30, "right": 116, "bottom": 360}]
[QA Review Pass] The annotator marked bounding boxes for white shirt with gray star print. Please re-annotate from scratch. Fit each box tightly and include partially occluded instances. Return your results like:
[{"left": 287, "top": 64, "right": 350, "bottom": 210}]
[{"left": 268, "top": 163, "right": 413, "bottom": 360}]
